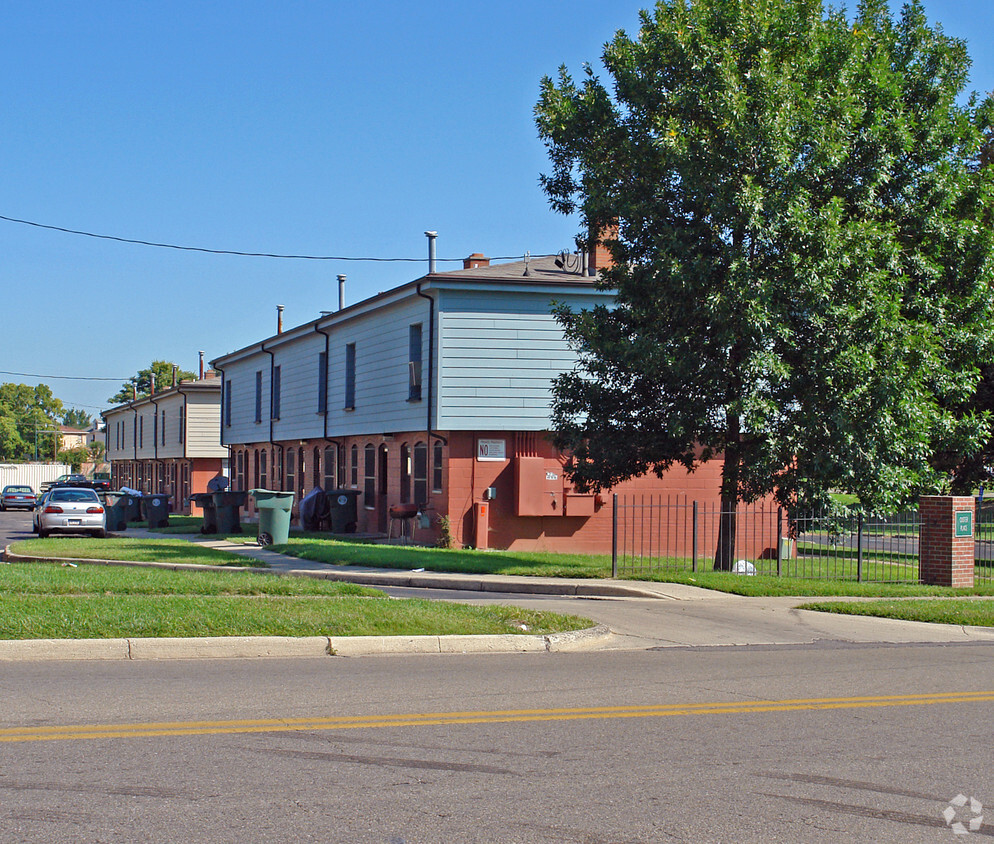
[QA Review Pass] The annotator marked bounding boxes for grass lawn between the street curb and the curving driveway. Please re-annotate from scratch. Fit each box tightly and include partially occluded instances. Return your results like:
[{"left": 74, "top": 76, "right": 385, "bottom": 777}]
[{"left": 0, "top": 563, "right": 591, "bottom": 639}]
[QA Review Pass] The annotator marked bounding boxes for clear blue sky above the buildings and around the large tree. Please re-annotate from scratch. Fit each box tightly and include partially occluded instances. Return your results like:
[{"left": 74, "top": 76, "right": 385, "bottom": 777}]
[{"left": 0, "top": 0, "right": 994, "bottom": 415}]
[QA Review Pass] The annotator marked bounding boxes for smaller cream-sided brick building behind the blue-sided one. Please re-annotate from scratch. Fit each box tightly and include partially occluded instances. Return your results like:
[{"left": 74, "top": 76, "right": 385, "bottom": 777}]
[{"left": 101, "top": 372, "right": 228, "bottom": 513}]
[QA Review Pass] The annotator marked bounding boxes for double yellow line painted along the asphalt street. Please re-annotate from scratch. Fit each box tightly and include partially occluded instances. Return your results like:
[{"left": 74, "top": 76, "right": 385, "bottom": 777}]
[{"left": 0, "top": 691, "right": 994, "bottom": 742}]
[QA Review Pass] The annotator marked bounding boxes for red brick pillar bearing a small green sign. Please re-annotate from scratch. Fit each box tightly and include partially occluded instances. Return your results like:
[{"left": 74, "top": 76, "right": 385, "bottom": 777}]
[{"left": 918, "top": 495, "right": 974, "bottom": 588}]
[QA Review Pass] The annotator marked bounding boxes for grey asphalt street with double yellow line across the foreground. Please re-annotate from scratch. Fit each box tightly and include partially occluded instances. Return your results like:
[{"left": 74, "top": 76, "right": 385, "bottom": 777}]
[{"left": 0, "top": 643, "right": 994, "bottom": 844}]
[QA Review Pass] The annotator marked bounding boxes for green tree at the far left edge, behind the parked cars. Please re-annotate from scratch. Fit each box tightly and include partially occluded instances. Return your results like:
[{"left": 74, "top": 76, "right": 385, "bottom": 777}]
[{"left": 0, "top": 384, "right": 63, "bottom": 460}]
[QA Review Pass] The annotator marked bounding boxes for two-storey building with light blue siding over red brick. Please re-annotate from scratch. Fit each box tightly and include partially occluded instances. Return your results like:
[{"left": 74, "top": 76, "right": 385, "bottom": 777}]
[{"left": 212, "top": 246, "right": 736, "bottom": 553}]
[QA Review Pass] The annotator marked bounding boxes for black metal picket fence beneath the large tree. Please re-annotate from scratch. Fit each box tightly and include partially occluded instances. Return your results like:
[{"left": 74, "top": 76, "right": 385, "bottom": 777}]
[{"left": 612, "top": 493, "right": 944, "bottom": 583}]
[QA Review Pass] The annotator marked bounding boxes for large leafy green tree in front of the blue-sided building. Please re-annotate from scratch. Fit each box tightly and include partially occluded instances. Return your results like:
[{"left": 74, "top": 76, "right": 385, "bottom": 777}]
[{"left": 536, "top": 0, "right": 994, "bottom": 568}]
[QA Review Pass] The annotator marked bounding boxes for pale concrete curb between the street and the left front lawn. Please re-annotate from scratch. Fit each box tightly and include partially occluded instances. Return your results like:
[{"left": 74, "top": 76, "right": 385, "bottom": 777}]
[{"left": 0, "top": 625, "right": 613, "bottom": 662}]
